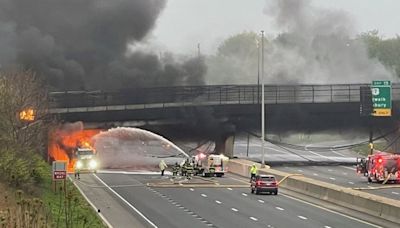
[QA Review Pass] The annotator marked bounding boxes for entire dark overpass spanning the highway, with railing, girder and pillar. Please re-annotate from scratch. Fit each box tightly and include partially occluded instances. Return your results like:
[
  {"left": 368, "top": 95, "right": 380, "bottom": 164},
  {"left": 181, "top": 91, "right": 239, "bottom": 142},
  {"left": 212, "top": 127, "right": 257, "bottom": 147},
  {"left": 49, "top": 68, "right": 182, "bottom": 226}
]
[{"left": 49, "top": 84, "right": 400, "bottom": 159}]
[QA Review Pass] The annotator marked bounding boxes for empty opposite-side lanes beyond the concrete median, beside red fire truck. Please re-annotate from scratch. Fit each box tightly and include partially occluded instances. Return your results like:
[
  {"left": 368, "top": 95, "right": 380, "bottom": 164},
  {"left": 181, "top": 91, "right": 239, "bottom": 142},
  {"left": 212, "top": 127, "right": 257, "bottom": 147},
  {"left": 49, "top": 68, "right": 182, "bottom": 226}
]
[{"left": 273, "top": 166, "right": 400, "bottom": 201}]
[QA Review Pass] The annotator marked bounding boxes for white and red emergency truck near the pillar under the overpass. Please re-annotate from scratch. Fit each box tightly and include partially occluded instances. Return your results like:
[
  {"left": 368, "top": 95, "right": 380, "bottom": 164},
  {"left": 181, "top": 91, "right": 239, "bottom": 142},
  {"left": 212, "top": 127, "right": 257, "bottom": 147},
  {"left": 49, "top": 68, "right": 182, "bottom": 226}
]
[{"left": 192, "top": 153, "right": 229, "bottom": 177}]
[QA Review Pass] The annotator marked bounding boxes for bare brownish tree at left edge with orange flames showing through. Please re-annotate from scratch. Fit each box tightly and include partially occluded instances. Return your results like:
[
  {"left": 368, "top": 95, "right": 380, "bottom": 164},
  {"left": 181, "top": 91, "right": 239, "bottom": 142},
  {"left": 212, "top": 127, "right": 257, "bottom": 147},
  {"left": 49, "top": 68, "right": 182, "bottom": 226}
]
[{"left": 0, "top": 69, "right": 49, "bottom": 157}]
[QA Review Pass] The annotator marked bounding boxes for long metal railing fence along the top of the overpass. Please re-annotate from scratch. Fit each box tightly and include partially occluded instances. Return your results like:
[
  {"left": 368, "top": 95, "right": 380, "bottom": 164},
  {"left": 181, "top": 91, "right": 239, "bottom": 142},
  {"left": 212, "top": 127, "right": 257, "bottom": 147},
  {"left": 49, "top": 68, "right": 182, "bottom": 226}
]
[{"left": 49, "top": 84, "right": 400, "bottom": 108}]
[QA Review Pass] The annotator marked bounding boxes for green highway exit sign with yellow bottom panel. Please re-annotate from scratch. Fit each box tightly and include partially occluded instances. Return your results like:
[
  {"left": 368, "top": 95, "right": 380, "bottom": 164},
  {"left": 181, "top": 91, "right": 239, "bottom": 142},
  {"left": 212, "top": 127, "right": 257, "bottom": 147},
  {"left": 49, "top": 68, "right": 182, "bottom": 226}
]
[{"left": 371, "top": 81, "right": 392, "bottom": 116}]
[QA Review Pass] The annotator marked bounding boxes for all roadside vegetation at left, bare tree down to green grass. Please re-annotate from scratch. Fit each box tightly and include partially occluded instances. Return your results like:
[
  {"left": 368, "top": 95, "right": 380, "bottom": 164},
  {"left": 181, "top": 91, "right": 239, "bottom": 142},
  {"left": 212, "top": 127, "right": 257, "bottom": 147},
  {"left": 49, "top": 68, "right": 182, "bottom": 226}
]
[{"left": 0, "top": 69, "right": 104, "bottom": 228}]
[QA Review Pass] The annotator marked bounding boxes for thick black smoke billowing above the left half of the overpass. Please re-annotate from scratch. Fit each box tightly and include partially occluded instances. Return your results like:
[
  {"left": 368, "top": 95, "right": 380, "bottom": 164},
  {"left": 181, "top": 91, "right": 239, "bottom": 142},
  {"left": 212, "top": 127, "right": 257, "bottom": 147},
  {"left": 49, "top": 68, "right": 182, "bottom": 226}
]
[{"left": 0, "top": 0, "right": 205, "bottom": 89}]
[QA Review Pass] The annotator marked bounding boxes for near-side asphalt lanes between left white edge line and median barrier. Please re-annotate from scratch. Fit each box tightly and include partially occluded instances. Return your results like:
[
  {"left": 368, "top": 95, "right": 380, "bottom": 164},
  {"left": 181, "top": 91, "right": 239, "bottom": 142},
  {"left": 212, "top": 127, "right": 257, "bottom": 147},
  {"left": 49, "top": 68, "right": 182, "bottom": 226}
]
[{"left": 97, "top": 173, "right": 384, "bottom": 228}]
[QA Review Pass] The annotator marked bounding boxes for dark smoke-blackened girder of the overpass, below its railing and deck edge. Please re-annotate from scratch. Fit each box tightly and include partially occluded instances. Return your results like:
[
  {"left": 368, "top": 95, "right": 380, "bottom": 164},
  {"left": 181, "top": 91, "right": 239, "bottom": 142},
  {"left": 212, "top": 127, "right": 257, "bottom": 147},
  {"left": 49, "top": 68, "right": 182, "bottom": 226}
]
[{"left": 55, "top": 102, "right": 399, "bottom": 130}]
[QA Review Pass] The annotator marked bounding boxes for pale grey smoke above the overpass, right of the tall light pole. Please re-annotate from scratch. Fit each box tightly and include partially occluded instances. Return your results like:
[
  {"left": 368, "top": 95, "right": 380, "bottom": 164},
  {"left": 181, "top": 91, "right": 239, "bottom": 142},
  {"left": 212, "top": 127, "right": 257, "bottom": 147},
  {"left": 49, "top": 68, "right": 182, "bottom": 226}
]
[{"left": 265, "top": 0, "right": 394, "bottom": 83}]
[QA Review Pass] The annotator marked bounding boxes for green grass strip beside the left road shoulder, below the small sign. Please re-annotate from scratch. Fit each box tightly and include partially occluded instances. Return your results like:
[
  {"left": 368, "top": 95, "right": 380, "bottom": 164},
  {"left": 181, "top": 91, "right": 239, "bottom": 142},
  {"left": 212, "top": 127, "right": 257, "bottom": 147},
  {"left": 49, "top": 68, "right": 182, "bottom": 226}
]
[{"left": 41, "top": 167, "right": 106, "bottom": 228}]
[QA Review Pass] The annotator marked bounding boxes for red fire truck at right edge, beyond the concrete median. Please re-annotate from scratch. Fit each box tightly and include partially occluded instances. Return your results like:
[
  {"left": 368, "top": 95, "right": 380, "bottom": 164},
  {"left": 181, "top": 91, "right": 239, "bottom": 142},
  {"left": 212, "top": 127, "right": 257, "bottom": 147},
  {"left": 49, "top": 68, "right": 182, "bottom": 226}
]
[{"left": 357, "top": 151, "right": 400, "bottom": 184}]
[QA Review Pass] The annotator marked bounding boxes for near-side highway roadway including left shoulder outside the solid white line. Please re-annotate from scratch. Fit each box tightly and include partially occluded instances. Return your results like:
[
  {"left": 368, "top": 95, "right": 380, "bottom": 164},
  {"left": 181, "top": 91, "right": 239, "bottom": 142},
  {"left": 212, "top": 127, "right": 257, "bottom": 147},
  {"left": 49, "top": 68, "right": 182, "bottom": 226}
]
[{"left": 72, "top": 172, "right": 388, "bottom": 228}]
